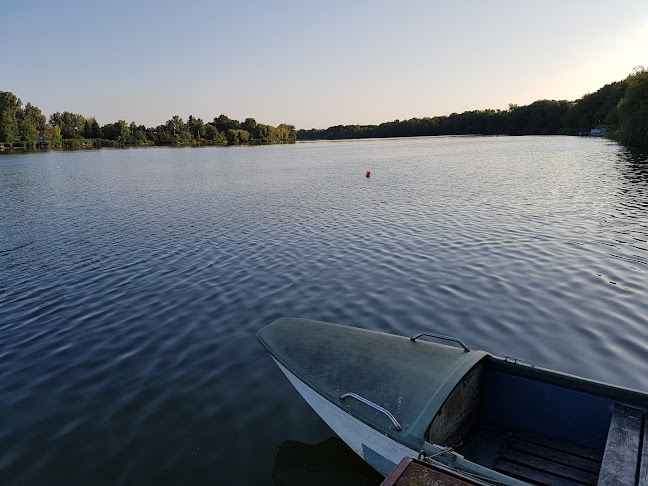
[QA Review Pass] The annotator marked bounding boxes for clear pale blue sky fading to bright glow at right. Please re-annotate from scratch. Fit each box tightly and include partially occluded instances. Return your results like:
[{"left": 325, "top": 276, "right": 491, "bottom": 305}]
[{"left": 0, "top": 0, "right": 648, "bottom": 129}]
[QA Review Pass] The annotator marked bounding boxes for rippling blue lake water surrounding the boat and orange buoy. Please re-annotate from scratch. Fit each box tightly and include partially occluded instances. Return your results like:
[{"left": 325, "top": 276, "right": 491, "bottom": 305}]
[{"left": 0, "top": 137, "right": 648, "bottom": 485}]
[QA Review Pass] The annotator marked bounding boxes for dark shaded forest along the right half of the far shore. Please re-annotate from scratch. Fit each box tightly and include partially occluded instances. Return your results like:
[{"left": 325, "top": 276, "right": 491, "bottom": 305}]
[{"left": 297, "top": 66, "right": 648, "bottom": 147}]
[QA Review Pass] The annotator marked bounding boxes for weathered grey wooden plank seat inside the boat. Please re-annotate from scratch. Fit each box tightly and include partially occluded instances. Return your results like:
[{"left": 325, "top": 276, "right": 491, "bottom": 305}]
[{"left": 597, "top": 403, "right": 648, "bottom": 486}]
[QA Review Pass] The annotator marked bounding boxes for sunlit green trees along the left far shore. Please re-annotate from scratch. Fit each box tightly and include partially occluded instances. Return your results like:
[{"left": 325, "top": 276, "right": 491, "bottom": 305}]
[{"left": 0, "top": 91, "right": 297, "bottom": 148}]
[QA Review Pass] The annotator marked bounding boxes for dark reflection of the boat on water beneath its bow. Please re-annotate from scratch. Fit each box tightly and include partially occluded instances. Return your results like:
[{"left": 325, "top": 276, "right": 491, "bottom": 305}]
[{"left": 272, "top": 437, "right": 384, "bottom": 486}]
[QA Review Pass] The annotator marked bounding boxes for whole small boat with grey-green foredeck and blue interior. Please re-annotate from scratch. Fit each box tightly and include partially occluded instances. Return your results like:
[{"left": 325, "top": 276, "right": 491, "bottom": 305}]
[{"left": 258, "top": 318, "right": 648, "bottom": 486}]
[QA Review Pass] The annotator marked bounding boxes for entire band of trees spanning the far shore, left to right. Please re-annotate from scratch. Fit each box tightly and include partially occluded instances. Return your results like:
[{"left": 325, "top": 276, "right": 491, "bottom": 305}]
[{"left": 0, "top": 66, "right": 648, "bottom": 150}]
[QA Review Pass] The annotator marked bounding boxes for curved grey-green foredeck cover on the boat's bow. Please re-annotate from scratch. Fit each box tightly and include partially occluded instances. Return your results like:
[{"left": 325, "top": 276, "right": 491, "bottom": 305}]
[{"left": 258, "top": 318, "right": 488, "bottom": 450}]
